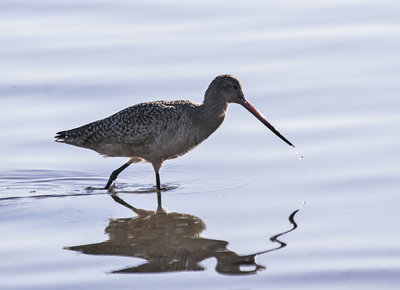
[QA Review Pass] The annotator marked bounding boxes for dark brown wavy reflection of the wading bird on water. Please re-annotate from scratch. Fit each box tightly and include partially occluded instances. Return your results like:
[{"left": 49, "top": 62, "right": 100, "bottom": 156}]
[{"left": 67, "top": 192, "right": 298, "bottom": 274}]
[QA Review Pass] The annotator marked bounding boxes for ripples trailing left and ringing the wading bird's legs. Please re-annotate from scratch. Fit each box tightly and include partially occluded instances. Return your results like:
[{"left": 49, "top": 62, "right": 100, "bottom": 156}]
[{"left": 0, "top": 170, "right": 249, "bottom": 201}]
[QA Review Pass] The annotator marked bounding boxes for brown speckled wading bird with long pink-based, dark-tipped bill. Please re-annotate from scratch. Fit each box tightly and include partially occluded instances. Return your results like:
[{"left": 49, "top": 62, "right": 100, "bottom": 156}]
[{"left": 55, "top": 75, "right": 294, "bottom": 190}]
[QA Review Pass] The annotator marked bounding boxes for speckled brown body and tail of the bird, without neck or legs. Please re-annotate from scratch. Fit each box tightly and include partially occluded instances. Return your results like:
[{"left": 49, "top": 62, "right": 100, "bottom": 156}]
[{"left": 56, "top": 101, "right": 205, "bottom": 159}]
